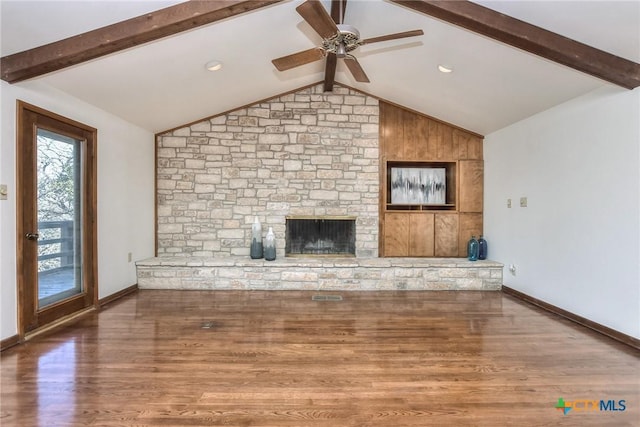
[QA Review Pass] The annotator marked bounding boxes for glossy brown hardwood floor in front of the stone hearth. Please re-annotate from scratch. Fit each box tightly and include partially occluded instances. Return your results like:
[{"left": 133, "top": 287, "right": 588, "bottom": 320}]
[{"left": 0, "top": 290, "right": 640, "bottom": 427}]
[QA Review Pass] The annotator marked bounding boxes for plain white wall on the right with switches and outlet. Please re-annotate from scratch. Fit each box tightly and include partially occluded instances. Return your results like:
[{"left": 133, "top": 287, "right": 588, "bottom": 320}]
[{"left": 484, "top": 87, "right": 640, "bottom": 338}]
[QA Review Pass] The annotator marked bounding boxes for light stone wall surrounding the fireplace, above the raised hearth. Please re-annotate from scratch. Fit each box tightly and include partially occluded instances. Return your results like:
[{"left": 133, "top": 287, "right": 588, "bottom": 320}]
[{"left": 157, "top": 85, "right": 379, "bottom": 258}]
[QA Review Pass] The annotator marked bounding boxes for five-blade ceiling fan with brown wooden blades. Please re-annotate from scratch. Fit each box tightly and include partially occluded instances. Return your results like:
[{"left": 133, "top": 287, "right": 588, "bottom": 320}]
[{"left": 271, "top": 0, "right": 424, "bottom": 92}]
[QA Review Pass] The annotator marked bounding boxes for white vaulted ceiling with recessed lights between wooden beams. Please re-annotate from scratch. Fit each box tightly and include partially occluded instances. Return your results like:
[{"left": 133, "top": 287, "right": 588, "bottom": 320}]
[{"left": 0, "top": 0, "right": 640, "bottom": 135}]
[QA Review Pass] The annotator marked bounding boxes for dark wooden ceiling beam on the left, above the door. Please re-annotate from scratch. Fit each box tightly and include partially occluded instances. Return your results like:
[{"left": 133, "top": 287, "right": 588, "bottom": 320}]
[{"left": 0, "top": 0, "right": 282, "bottom": 83}]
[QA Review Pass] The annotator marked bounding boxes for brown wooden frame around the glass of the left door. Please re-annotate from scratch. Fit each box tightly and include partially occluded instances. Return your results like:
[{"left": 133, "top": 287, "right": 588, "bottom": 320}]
[{"left": 16, "top": 100, "right": 98, "bottom": 341}]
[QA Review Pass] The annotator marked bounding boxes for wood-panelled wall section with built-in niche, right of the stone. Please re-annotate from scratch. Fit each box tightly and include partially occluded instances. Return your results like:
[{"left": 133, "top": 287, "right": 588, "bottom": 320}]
[{"left": 379, "top": 101, "right": 484, "bottom": 257}]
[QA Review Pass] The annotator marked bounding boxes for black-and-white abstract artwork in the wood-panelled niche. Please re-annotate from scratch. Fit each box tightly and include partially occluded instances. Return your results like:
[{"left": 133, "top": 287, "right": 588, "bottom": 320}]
[{"left": 389, "top": 166, "right": 447, "bottom": 205}]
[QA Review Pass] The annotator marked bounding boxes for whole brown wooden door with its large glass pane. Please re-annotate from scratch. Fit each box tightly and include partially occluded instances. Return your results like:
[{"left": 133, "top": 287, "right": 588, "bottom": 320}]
[{"left": 16, "top": 101, "right": 98, "bottom": 338}]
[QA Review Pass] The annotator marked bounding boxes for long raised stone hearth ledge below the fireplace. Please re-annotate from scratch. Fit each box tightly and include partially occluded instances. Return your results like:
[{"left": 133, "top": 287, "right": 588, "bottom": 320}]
[{"left": 136, "top": 256, "right": 504, "bottom": 291}]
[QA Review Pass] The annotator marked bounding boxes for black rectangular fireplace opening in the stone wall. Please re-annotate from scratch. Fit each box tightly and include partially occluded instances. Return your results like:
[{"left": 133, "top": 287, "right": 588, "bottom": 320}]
[{"left": 285, "top": 216, "right": 356, "bottom": 257}]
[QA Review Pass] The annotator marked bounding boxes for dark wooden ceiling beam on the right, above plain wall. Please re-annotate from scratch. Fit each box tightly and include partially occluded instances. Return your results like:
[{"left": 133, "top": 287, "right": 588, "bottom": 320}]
[{"left": 391, "top": 0, "right": 640, "bottom": 89}]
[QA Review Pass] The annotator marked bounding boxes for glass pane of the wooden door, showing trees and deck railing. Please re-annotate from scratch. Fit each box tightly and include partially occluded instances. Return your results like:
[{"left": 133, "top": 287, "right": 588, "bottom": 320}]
[{"left": 36, "top": 128, "right": 83, "bottom": 309}]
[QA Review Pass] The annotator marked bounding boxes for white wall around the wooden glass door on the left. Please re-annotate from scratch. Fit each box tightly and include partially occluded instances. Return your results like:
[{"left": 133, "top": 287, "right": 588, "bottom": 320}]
[{"left": 0, "top": 82, "right": 154, "bottom": 339}]
